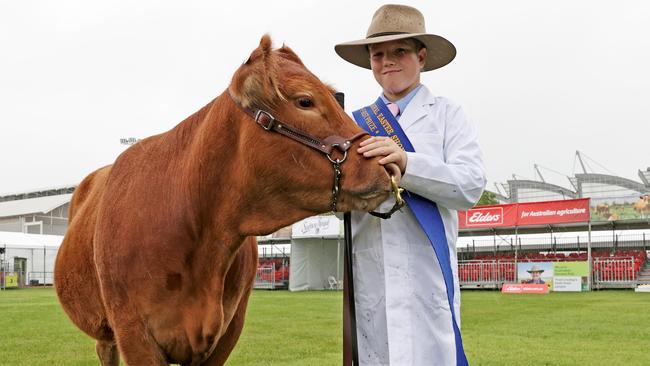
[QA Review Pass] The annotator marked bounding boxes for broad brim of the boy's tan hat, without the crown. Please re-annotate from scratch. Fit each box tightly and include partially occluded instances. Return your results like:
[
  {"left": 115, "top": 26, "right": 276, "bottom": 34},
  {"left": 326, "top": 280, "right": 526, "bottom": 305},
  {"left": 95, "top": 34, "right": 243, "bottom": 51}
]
[{"left": 334, "top": 33, "right": 456, "bottom": 71}]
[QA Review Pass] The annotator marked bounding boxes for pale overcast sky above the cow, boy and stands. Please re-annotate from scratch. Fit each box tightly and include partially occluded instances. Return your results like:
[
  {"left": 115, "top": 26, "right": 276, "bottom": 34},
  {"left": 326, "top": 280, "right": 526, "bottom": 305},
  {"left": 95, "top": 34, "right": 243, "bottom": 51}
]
[{"left": 0, "top": 0, "right": 650, "bottom": 194}]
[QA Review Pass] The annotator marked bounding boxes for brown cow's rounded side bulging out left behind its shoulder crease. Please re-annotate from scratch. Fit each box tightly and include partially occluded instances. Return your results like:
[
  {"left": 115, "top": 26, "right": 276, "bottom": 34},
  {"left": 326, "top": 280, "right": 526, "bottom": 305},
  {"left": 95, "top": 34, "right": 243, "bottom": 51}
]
[{"left": 54, "top": 166, "right": 113, "bottom": 340}]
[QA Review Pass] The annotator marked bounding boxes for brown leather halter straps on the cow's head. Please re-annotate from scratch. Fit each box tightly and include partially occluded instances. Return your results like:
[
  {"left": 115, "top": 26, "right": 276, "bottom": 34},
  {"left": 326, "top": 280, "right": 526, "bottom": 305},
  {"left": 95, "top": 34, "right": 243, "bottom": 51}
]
[{"left": 228, "top": 88, "right": 368, "bottom": 212}]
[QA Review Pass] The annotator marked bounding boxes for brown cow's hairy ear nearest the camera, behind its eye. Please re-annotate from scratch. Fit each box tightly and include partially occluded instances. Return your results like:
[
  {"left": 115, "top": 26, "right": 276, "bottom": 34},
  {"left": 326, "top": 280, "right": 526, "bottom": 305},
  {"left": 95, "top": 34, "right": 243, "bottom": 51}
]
[{"left": 230, "top": 34, "right": 282, "bottom": 109}]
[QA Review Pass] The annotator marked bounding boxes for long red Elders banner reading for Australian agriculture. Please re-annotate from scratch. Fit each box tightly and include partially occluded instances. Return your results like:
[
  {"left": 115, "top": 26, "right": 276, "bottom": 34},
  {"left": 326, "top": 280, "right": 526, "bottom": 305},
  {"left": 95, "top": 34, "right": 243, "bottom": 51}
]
[{"left": 458, "top": 198, "right": 590, "bottom": 229}]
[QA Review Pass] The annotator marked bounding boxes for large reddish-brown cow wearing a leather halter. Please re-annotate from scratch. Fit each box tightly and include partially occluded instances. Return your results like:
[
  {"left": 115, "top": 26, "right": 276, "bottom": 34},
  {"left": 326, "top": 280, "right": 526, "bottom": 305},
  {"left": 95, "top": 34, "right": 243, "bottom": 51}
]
[{"left": 55, "top": 36, "right": 390, "bottom": 365}]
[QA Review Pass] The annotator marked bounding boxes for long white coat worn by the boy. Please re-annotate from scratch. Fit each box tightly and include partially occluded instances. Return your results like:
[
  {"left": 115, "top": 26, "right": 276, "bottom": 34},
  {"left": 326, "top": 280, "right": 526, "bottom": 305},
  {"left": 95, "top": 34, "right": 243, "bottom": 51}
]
[{"left": 352, "top": 86, "right": 486, "bottom": 366}]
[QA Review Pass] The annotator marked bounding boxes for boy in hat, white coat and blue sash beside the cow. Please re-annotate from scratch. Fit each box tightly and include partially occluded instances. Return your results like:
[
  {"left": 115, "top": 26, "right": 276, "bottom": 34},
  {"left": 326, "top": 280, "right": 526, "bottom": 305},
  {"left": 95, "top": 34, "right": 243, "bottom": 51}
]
[{"left": 335, "top": 5, "right": 486, "bottom": 366}]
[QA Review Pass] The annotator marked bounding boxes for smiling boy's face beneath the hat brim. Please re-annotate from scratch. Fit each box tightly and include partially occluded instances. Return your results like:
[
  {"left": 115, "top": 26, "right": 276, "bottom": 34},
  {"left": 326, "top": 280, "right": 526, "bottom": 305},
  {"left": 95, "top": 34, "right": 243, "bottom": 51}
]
[{"left": 368, "top": 40, "right": 427, "bottom": 101}]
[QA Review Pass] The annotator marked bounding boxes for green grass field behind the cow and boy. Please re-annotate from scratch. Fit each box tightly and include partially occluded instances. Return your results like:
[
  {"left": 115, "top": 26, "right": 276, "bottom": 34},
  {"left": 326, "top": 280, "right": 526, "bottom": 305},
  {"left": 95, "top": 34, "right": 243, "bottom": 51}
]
[{"left": 0, "top": 289, "right": 650, "bottom": 366}]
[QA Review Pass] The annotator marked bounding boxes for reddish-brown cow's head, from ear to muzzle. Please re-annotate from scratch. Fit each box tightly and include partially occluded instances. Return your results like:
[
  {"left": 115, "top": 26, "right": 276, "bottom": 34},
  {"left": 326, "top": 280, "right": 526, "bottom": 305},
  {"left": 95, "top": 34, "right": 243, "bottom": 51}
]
[{"left": 229, "top": 36, "right": 390, "bottom": 229}]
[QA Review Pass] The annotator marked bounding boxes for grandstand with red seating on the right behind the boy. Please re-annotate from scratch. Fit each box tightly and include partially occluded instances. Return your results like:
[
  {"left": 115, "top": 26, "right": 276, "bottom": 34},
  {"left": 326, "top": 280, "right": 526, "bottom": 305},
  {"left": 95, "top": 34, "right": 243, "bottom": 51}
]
[{"left": 458, "top": 157, "right": 650, "bottom": 289}]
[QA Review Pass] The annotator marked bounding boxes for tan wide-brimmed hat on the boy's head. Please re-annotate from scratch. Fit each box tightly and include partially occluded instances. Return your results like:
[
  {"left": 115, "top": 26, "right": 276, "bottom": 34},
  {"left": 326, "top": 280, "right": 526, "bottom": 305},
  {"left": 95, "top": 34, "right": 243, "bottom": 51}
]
[{"left": 334, "top": 4, "right": 456, "bottom": 71}]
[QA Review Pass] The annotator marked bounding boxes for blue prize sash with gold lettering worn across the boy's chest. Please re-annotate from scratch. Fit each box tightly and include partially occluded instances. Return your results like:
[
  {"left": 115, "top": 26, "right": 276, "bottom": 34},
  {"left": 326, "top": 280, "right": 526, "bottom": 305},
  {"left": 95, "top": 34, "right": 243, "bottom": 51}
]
[{"left": 352, "top": 98, "right": 469, "bottom": 366}]
